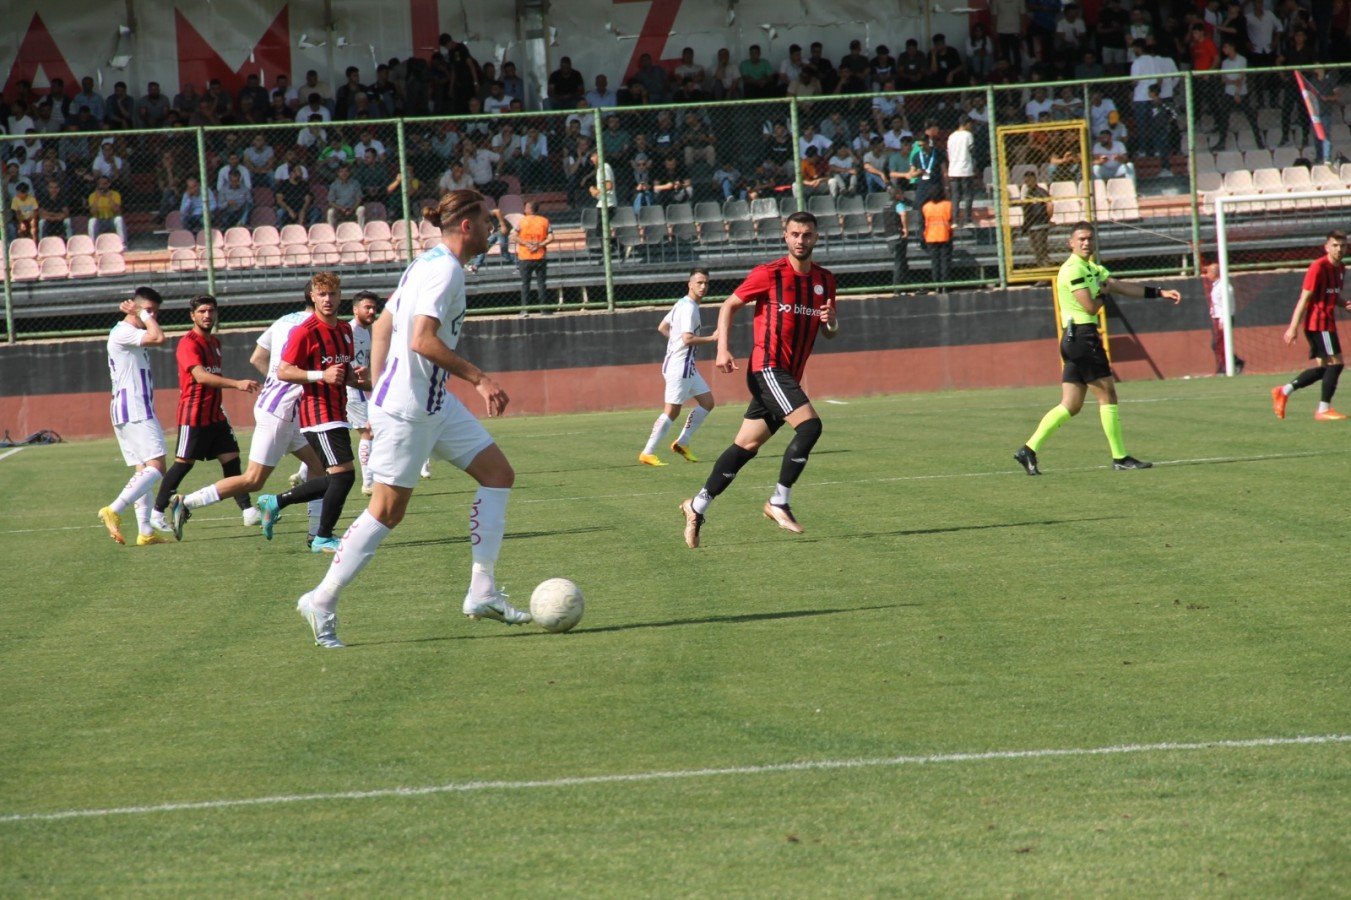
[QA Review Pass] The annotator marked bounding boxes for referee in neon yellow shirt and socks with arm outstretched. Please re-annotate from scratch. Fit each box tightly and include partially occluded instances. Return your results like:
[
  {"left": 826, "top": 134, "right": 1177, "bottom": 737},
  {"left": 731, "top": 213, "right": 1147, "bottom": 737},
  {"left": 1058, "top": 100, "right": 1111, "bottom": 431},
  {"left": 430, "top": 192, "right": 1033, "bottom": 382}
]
[{"left": 1013, "top": 222, "right": 1182, "bottom": 474}]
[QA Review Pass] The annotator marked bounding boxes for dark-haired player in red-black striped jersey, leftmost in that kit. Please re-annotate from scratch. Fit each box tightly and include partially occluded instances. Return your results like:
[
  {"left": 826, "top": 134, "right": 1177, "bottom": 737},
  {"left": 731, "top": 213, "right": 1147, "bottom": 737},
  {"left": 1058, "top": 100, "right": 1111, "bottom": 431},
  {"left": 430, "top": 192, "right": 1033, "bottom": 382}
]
[{"left": 151, "top": 295, "right": 258, "bottom": 539}]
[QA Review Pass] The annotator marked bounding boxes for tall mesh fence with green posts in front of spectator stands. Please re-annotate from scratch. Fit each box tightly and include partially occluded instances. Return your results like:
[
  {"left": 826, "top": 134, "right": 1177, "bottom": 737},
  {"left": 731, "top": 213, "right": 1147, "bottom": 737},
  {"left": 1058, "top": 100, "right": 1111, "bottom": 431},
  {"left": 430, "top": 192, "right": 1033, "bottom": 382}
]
[{"left": 0, "top": 60, "right": 1351, "bottom": 342}]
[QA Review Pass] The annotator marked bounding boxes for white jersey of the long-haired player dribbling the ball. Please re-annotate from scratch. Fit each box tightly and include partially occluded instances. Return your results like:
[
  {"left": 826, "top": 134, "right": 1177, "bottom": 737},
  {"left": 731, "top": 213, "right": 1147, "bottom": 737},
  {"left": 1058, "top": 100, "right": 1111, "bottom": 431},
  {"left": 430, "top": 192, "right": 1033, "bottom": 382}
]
[{"left": 374, "top": 243, "right": 467, "bottom": 419}]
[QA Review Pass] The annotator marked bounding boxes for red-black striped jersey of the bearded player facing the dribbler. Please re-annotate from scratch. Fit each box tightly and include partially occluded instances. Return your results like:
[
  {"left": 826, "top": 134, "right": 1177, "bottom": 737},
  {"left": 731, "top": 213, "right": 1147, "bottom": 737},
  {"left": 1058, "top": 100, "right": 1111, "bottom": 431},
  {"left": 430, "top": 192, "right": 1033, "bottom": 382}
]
[{"left": 734, "top": 257, "right": 835, "bottom": 381}]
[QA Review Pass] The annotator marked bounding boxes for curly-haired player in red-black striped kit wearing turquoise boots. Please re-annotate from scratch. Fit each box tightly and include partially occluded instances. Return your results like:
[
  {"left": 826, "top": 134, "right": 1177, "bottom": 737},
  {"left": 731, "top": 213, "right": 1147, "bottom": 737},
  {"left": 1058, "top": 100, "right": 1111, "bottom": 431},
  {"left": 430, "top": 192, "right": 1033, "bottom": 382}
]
[{"left": 258, "top": 272, "right": 370, "bottom": 553}]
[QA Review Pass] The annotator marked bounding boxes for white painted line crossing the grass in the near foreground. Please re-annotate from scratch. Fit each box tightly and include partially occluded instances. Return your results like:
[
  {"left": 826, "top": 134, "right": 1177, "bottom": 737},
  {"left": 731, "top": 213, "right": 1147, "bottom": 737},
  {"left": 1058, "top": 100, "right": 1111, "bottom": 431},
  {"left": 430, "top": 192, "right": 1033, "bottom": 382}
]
[{"left": 0, "top": 734, "right": 1351, "bottom": 823}]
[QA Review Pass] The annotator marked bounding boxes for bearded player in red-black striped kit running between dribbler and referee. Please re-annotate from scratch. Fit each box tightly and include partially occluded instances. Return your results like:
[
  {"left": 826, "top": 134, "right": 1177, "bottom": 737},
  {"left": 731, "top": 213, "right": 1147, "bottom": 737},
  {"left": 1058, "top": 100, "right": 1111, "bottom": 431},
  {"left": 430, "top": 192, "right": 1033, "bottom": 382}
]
[{"left": 680, "top": 212, "right": 839, "bottom": 547}]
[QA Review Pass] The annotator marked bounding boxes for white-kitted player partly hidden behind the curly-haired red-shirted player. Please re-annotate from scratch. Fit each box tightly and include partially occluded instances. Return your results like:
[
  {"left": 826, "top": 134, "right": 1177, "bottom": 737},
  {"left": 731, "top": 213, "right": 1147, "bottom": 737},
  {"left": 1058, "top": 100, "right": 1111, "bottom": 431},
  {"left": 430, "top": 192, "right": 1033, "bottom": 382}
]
[{"left": 174, "top": 290, "right": 323, "bottom": 541}]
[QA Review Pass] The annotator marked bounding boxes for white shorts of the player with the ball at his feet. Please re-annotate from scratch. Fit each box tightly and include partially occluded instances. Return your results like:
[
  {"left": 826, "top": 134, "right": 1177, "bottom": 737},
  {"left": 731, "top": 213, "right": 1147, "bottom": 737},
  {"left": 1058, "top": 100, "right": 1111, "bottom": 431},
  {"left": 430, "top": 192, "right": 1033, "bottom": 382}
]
[{"left": 366, "top": 393, "right": 494, "bottom": 488}]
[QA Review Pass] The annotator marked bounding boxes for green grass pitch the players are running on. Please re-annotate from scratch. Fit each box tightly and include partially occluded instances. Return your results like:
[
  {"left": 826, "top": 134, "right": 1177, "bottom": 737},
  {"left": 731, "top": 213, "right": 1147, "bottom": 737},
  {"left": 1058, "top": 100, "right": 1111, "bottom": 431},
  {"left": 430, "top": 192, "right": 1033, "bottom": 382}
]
[{"left": 0, "top": 378, "right": 1351, "bottom": 897}]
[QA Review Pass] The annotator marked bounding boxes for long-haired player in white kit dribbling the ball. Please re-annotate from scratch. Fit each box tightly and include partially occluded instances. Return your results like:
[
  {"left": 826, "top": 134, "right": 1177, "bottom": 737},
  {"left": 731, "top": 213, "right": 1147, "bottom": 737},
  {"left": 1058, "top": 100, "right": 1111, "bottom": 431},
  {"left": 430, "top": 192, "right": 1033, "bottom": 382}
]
[{"left": 296, "top": 191, "right": 531, "bottom": 649}]
